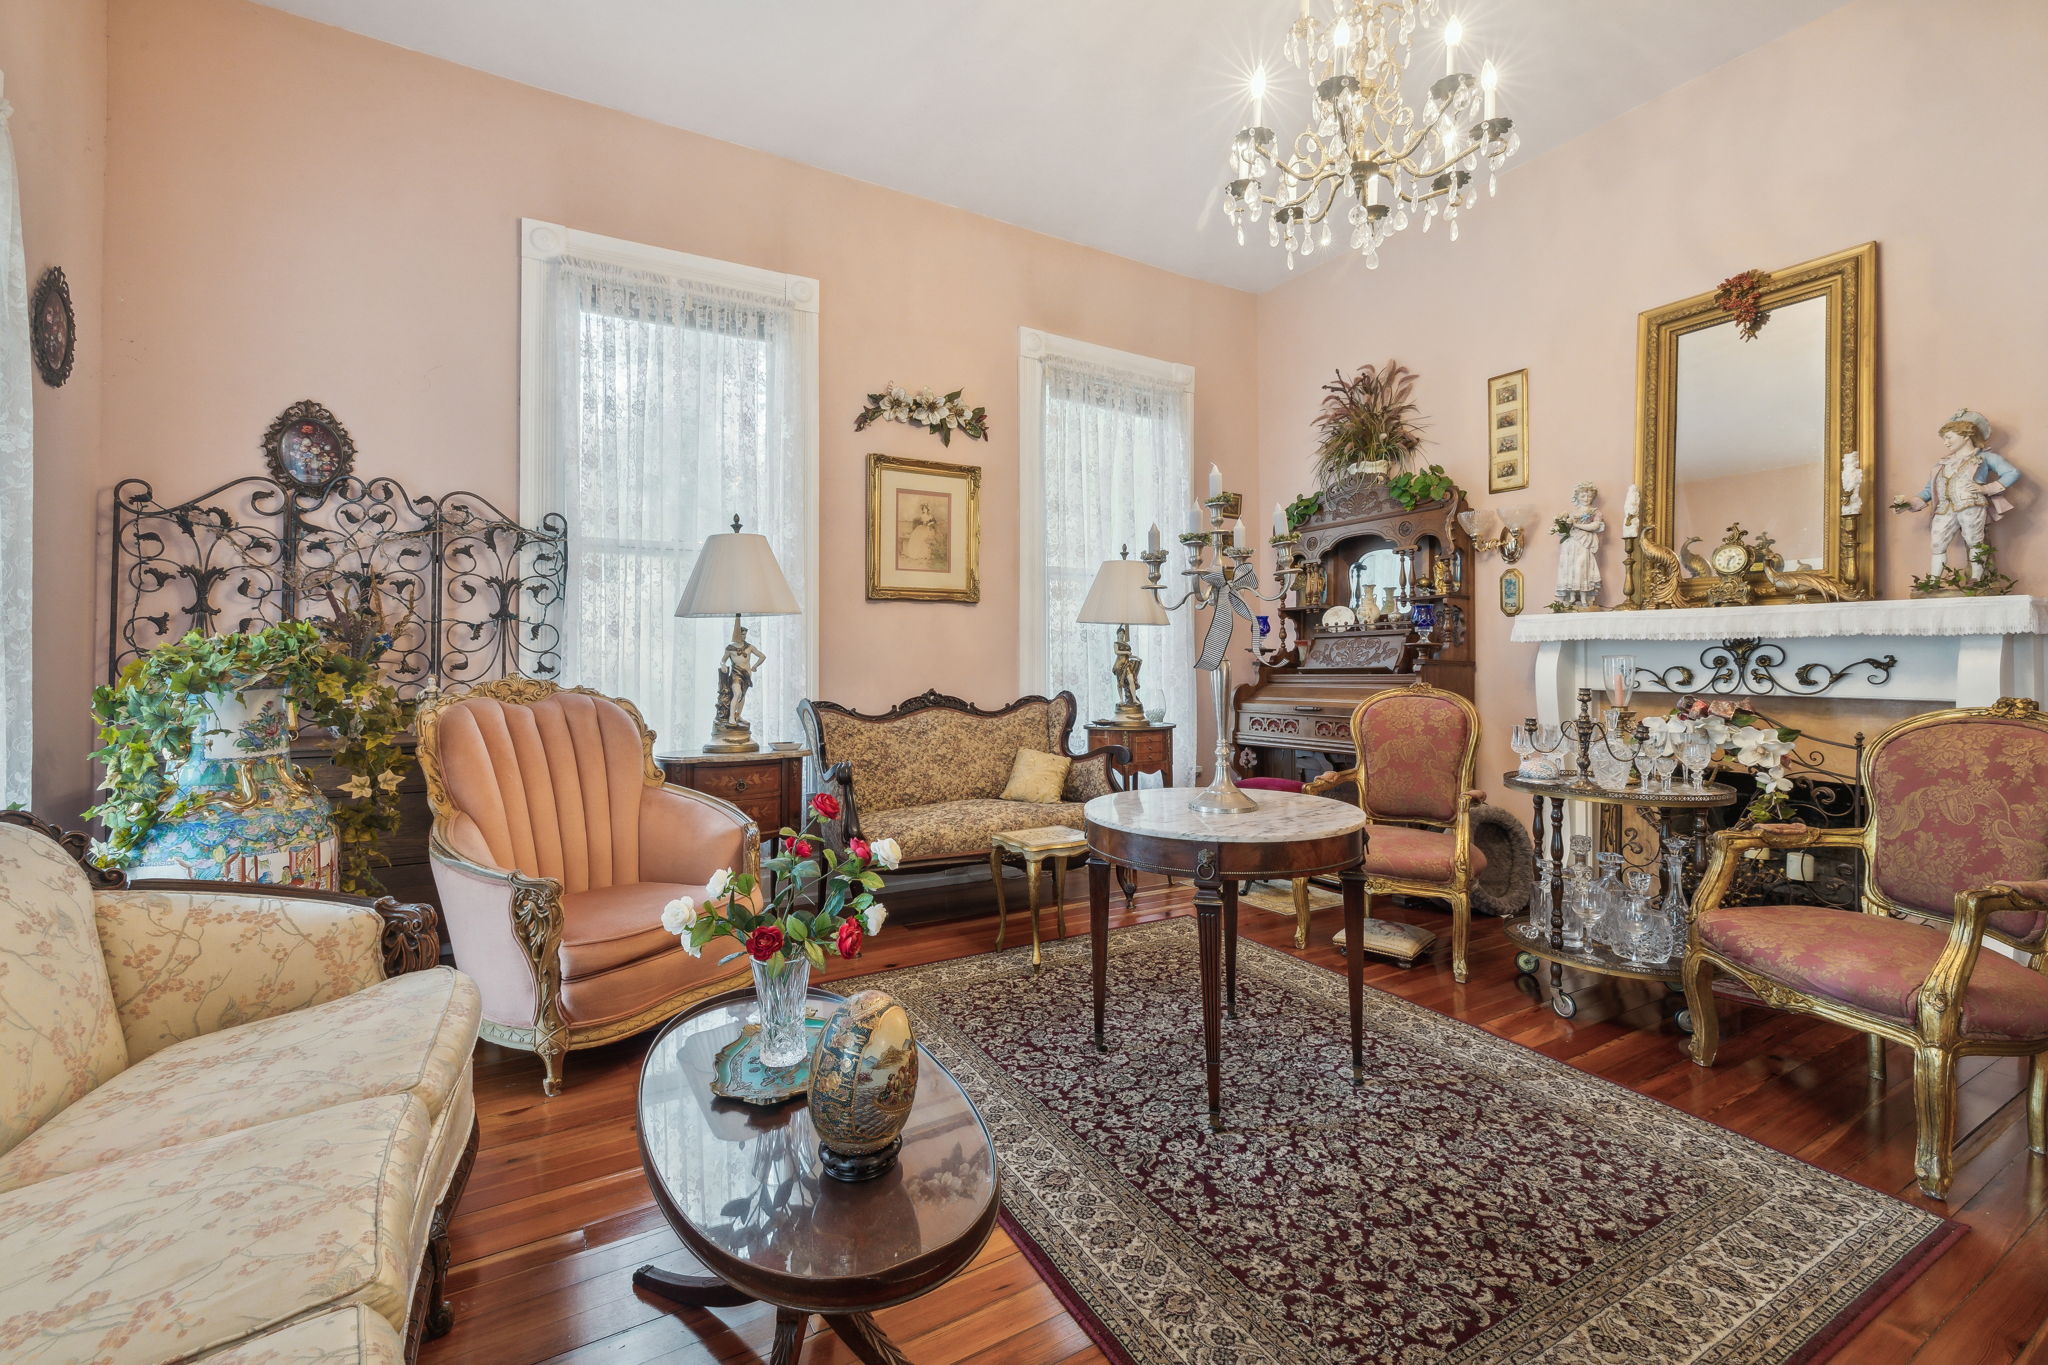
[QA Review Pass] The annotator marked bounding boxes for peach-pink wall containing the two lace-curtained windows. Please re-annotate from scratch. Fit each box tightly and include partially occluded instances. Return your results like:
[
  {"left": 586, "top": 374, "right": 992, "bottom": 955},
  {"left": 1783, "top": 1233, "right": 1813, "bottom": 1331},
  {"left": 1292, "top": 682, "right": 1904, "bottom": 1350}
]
[{"left": 100, "top": 0, "right": 1257, "bottom": 769}]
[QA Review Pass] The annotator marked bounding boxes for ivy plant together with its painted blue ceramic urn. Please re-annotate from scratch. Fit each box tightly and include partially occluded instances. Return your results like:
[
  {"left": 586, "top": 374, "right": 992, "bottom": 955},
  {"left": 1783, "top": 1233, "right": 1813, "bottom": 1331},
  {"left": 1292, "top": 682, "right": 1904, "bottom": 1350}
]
[{"left": 86, "top": 620, "right": 412, "bottom": 892}]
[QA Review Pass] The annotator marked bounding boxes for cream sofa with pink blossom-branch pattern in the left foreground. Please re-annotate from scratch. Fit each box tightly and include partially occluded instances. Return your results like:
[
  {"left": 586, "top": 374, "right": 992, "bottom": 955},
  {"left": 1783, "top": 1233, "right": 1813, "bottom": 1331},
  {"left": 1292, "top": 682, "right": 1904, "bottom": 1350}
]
[{"left": 0, "top": 810, "right": 477, "bottom": 1365}]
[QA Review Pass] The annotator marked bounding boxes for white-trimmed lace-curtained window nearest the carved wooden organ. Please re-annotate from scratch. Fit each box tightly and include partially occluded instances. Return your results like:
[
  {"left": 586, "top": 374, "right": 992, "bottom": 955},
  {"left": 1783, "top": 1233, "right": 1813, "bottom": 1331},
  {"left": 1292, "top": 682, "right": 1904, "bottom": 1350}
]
[{"left": 1020, "top": 327, "right": 1196, "bottom": 782}]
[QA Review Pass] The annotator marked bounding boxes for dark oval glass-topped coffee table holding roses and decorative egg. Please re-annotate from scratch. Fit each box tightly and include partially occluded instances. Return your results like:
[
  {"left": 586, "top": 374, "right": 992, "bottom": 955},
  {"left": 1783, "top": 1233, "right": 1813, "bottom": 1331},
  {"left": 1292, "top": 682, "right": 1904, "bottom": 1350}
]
[{"left": 633, "top": 990, "right": 999, "bottom": 1365}]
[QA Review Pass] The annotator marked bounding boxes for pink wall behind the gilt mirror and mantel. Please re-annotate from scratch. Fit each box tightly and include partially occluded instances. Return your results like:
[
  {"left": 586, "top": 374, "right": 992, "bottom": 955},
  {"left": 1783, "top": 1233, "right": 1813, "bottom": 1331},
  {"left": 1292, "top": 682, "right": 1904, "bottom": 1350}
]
[{"left": 1257, "top": 0, "right": 2048, "bottom": 782}]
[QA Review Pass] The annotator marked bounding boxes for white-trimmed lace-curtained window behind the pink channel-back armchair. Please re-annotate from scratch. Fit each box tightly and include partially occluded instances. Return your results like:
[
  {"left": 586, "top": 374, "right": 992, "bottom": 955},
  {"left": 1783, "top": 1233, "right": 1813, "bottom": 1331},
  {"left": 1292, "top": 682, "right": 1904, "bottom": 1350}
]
[{"left": 520, "top": 228, "right": 817, "bottom": 749}]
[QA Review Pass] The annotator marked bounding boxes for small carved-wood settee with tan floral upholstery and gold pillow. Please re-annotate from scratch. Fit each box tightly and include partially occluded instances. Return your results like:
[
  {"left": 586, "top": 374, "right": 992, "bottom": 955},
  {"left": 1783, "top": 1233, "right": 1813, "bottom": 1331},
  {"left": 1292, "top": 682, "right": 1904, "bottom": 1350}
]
[{"left": 797, "top": 692, "right": 1130, "bottom": 870}]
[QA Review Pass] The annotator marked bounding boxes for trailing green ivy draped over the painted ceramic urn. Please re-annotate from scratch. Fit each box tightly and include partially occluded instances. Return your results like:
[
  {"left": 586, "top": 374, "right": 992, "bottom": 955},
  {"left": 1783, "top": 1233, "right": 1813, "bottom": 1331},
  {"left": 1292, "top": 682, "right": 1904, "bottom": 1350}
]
[{"left": 86, "top": 620, "right": 412, "bottom": 894}]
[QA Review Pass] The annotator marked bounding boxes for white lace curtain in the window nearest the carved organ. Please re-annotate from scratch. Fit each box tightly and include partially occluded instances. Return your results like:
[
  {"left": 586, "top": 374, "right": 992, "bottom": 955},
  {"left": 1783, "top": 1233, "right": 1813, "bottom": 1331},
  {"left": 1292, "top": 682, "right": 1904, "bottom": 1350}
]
[{"left": 1026, "top": 352, "right": 1196, "bottom": 782}]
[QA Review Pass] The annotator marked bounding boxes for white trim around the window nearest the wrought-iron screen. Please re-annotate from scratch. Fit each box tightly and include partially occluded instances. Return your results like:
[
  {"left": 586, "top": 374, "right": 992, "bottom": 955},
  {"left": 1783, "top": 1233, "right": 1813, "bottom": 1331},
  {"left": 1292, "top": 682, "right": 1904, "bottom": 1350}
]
[{"left": 516, "top": 219, "right": 819, "bottom": 692}]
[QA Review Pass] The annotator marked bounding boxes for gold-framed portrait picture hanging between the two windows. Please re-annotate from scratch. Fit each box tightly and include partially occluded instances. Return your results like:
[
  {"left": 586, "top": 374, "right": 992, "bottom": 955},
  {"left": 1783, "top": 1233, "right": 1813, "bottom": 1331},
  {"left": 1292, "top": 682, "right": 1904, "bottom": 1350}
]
[{"left": 868, "top": 454, "right": 981, "bottom": 602}]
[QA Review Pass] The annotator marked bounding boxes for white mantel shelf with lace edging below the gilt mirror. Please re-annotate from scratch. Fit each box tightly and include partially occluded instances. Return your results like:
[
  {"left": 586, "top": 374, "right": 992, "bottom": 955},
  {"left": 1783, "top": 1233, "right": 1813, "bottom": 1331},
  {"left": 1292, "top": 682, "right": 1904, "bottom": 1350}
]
[{"left": 1511, "top": 596, "right": 2048, "bottom": 645}]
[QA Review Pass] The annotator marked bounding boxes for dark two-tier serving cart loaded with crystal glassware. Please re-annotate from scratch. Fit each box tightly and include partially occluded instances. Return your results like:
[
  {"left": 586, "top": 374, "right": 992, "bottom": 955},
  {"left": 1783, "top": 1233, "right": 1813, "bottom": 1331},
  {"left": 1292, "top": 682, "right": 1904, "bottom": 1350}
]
[{"left": 1501, "top": 688, "right": 1739, "bottom": 1033}]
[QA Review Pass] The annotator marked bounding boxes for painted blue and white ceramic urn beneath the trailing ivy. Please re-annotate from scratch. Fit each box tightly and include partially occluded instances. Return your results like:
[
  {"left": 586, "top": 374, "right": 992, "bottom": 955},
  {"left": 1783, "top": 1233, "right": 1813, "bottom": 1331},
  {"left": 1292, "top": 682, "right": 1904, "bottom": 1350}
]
[{"left": 129, "top": 688, "right": 340, "bottom": 890}]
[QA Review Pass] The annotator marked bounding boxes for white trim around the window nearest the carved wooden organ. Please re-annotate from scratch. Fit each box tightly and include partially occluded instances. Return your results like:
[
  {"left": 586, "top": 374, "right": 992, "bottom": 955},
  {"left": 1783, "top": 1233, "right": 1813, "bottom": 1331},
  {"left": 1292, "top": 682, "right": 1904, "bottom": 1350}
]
[{"left": 1018, "top": 327, "right": 1200, "bottom": 694}]
